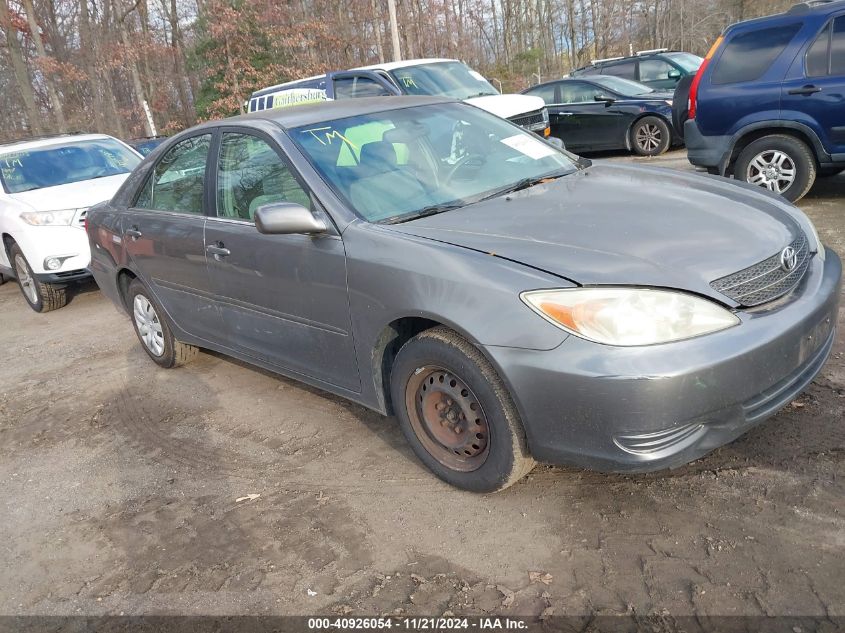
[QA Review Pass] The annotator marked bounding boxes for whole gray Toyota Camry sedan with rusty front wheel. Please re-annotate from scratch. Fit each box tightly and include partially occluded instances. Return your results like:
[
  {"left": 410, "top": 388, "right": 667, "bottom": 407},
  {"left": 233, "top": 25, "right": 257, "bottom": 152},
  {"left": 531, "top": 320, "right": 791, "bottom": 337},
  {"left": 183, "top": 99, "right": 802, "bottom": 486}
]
[{"left": 88, "top": 97, "right": 841, "bottom": 492}]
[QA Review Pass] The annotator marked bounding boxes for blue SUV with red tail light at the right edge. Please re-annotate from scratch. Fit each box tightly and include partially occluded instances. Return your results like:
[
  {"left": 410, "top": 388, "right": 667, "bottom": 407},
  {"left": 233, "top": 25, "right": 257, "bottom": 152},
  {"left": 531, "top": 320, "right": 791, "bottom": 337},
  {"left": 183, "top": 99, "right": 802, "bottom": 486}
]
[{"left": 675, "top": 0, "right": 845, "bottom": 202}]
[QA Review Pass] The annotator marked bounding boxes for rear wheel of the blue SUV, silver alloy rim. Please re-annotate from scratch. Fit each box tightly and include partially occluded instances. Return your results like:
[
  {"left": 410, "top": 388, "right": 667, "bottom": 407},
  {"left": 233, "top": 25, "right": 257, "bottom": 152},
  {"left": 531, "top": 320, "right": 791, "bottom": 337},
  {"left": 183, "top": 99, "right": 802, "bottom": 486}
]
[{"left": 733, "top": 134, "right": 817, "bottom": 202}]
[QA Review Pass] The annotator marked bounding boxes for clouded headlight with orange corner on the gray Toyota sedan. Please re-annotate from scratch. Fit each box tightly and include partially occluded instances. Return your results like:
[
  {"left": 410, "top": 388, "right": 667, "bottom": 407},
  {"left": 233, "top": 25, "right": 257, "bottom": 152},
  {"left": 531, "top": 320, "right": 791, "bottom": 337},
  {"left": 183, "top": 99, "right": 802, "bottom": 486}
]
[{"left": 520, "top": 288, "right": 740, "bottom": 347}]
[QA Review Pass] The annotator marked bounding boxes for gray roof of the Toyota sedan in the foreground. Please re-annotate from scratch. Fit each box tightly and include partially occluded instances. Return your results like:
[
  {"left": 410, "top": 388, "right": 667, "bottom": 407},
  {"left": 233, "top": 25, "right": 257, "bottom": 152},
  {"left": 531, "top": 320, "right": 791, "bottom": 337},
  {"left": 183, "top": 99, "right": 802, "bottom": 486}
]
[{"left": 198, "top": 96, "right": 454, "bottom": 129}]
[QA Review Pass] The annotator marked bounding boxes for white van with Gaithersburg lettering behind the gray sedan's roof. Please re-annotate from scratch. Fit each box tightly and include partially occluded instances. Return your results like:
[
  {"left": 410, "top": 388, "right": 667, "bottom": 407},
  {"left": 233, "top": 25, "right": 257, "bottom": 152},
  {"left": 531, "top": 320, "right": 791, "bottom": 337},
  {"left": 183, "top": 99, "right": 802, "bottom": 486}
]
[{"left": 248, "top": 59, "right": 550, "bottom": 137}]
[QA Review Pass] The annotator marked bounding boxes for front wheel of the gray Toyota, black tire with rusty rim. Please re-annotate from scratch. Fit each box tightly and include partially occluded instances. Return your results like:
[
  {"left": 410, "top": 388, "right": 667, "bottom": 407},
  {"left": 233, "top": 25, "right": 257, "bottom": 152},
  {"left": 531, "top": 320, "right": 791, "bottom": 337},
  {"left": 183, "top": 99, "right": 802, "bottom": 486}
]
[{"left": 390, "top": 327, "right": 534, "bottom": 492}]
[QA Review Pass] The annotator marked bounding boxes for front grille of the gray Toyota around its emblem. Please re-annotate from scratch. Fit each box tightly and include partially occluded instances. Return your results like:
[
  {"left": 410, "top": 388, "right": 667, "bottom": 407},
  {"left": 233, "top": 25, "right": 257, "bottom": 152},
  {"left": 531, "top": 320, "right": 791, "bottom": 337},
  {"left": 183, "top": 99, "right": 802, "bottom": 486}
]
[{"left": 710, "top": 234, "right": 812, "bottom": 307}]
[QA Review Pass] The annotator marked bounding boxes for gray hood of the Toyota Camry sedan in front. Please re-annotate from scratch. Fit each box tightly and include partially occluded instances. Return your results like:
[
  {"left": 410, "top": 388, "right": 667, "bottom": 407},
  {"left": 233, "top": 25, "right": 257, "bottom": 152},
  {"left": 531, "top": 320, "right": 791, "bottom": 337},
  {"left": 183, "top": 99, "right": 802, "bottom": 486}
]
[{"left": 390, "top": 164, "right": 801, "bottom": 305}]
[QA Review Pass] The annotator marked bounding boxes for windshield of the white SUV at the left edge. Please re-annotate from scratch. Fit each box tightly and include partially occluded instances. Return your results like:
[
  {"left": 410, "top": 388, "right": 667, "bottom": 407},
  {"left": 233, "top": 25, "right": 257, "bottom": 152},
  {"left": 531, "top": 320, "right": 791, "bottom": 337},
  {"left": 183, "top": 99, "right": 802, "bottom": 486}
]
[{"left": 0, "top": 139, "right": 141, "bottom": 193}]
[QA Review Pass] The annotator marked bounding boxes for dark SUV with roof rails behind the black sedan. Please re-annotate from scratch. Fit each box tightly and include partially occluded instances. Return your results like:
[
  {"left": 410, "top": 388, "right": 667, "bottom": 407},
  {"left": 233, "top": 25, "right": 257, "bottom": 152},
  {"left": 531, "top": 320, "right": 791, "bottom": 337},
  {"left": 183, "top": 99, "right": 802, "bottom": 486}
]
[{"left": 570, "top": 48, "right": 703, "bottom": 90}]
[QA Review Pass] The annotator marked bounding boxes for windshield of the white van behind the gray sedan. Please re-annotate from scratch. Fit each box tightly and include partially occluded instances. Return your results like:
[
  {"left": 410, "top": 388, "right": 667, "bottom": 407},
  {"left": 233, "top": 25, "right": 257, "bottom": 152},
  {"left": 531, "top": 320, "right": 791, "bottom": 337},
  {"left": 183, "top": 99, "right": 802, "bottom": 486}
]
[{"left": 390, "top": 62, "right": 499, "bottom": 99}]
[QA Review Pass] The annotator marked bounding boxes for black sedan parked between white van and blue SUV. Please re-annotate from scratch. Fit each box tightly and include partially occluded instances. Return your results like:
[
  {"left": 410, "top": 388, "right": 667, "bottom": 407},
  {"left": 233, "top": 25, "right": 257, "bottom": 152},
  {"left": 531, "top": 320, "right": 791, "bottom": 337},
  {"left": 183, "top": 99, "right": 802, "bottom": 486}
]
[{"left": 524, "top": 75, "right": 678, "bottom": 156}]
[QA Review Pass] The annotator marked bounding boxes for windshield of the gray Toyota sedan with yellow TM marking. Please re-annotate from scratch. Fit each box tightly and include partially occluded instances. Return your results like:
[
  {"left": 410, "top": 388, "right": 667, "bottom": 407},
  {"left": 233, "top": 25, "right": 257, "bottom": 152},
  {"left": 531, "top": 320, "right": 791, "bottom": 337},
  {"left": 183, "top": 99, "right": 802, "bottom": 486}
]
[{"left": 290, "top": 103, "right": 579, "bottom": 222}]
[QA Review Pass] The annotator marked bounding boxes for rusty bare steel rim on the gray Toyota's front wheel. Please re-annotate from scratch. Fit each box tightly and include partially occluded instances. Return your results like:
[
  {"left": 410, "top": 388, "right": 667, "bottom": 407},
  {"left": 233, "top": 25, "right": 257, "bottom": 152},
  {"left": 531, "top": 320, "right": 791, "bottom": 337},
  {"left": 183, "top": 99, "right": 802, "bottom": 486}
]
[{"left": 405, "top": 366, "right": 490, "bottom": 472}]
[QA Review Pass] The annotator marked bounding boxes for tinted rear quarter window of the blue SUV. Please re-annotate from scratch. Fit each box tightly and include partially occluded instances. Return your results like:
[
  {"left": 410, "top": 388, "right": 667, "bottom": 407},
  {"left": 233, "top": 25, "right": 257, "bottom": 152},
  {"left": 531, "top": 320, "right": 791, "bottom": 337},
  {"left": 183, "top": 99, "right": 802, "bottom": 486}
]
[{"left": 712, "top": 22, "right": 802, "bottom": 85}]
